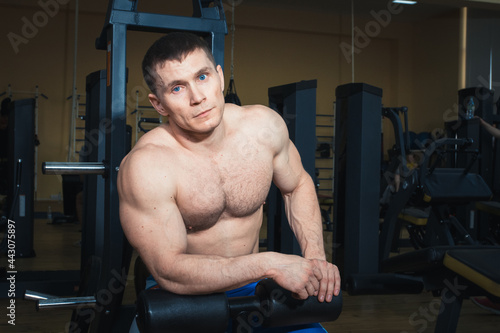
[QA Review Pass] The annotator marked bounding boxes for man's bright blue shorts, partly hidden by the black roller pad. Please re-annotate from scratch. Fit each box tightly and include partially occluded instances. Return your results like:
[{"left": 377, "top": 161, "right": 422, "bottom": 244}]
[{"left": 130, "top": 276, "right": 327, "bottom": 333}]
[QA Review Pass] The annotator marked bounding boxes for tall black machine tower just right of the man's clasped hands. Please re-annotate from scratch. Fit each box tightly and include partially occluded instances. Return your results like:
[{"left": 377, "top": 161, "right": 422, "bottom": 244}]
[{"left": 332, "top": 83, "right": 382, "bottom": 278}]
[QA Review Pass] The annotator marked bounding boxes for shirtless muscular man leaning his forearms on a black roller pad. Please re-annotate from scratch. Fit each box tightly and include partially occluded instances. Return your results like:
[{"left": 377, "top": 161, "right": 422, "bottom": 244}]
[{"left": 118, "top": 33, "right": 340, "bottom": 332}]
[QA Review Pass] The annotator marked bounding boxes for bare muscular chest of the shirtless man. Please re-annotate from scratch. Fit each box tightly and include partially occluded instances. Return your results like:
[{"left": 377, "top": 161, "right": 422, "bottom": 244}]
[{"left": 177, "top": 154, "right": 272, "bottom": 231}]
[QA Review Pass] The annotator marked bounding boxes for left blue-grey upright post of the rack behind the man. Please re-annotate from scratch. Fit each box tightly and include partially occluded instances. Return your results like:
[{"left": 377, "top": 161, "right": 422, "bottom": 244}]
[{"left": 93, "top": 23, "right": 129, "bottom": 333}]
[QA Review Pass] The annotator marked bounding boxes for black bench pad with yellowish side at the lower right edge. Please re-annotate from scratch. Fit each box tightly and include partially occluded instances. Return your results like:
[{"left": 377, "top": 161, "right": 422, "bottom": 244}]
[{"left": 443, "top": 248, "right": 500, "bottom": 297}]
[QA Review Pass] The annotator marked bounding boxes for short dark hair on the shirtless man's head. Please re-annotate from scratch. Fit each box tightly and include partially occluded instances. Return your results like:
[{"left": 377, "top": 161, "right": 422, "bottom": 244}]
[{"left": 142, "top": 32, "right": 216, "bottom": 95}]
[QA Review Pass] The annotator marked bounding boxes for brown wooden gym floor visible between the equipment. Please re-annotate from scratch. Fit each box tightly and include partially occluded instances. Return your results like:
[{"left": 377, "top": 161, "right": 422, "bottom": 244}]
[{"left": 0, "top": 203, "right": 500, "bottom": 333}]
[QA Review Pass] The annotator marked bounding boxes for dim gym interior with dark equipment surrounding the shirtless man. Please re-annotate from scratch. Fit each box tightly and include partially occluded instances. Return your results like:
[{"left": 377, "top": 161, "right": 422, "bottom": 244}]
[{"left": 0, "top": 0, "right": 500, "bottom": 333}]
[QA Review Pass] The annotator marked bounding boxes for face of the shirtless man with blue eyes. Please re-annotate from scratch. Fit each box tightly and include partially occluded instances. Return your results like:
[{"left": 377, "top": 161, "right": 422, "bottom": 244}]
[{"left": 149, "top": 49, "right": 224, "bottom": 134}]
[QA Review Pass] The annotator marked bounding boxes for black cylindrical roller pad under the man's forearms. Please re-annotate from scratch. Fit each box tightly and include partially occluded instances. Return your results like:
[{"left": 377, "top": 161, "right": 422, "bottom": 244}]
[{"left": 137, "top": 279, "right": 342, "bottom": 333}]
